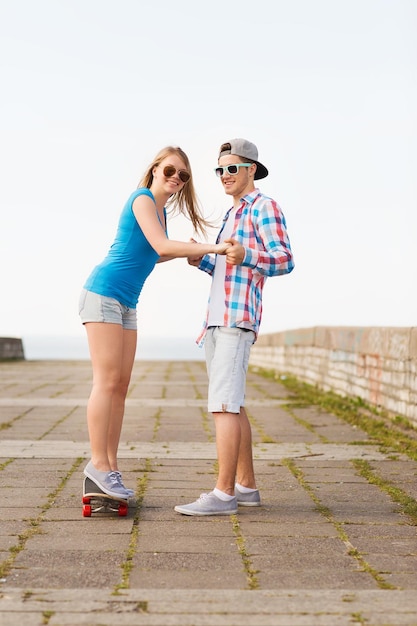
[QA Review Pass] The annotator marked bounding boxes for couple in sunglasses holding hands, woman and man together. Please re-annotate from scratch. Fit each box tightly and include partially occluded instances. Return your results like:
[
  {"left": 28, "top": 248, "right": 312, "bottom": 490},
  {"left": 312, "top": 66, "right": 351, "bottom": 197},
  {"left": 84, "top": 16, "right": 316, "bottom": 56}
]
[{"left": 79, "top": 139, "right": 294, "bottom": 516}]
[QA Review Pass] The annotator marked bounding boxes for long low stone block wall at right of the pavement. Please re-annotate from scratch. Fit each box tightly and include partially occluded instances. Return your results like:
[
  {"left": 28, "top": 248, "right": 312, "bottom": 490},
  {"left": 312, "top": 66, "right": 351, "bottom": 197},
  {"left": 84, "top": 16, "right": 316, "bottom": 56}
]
[{"left": 250, "top": 326, "right": 417, "bottom": 426}]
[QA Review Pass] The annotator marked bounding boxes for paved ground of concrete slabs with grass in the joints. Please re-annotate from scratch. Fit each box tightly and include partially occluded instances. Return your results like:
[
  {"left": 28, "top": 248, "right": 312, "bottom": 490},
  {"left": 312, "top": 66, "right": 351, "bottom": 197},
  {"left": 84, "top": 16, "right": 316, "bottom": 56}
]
[{"left": 0, "top": 361, "right": 417, "bottom": 626}]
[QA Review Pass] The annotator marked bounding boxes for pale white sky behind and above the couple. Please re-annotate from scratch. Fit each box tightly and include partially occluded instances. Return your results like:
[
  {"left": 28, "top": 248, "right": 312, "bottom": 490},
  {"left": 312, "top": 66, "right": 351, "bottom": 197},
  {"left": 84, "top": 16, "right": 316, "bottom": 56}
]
[{"left": 0, "top": 0, "right": 417, "bottom": 356}]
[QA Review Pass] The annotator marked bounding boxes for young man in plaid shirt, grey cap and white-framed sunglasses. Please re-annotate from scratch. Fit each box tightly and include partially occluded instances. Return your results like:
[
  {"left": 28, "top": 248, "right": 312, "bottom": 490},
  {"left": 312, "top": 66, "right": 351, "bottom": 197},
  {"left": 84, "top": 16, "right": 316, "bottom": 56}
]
[{"left": 175, "top": 139, "right": 294, "bottom": 515}]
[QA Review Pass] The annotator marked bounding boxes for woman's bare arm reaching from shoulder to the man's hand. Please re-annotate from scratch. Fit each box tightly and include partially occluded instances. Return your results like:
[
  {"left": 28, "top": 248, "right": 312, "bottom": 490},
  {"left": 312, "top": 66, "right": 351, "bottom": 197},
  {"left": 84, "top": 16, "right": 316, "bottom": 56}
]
[{"left": 132, "top": 195, "right": 229, "bottom": 255}]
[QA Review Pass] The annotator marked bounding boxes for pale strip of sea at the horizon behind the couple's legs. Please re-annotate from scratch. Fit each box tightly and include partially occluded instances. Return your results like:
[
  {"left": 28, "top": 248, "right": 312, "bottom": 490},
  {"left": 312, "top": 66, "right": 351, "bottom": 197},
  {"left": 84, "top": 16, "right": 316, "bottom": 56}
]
[{"left": 22, "top": 335, "right": 205, "bottom": 361}]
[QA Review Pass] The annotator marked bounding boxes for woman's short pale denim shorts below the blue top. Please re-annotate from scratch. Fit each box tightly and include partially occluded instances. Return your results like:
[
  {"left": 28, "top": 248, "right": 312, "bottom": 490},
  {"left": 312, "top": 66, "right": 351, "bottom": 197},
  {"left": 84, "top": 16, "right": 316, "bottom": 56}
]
[{"left": 78, "top": 289, "right": 137, "bottom": 330}]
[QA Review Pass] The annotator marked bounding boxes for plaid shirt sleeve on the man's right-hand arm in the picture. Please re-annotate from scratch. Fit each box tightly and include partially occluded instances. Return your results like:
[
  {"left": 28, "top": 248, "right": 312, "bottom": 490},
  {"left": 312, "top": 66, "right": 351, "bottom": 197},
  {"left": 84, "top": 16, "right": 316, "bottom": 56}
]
[{"left": 242, "top": 199, "right": 294, "bottom": 276}]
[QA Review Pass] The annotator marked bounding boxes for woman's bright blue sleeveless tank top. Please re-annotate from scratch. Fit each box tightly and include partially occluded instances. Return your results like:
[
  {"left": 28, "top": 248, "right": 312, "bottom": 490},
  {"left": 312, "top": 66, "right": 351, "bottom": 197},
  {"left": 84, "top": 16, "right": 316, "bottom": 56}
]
[{"left": 84, "top": 187, "right": 166, "bottom": 309}]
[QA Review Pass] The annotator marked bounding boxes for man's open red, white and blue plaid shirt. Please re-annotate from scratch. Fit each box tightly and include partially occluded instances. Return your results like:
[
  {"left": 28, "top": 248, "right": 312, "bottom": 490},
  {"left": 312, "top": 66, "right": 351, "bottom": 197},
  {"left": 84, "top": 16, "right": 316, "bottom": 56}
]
[{"left": 197, "top": 189, "right": 294, "bottom": 345}]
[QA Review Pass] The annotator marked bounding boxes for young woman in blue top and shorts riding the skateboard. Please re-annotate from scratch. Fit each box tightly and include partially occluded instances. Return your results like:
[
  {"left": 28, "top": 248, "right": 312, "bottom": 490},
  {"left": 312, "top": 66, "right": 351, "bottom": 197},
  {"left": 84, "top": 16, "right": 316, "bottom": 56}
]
[{"left": 79, "top": 146, "right": 228, "bottom": 498}]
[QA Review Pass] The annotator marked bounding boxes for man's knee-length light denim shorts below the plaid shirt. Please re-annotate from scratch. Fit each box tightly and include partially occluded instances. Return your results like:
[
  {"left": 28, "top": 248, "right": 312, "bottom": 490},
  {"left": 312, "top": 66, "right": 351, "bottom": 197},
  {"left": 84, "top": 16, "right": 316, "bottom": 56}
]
[{"left": 205, "top": 326, "right": 255, "bottom": 413}]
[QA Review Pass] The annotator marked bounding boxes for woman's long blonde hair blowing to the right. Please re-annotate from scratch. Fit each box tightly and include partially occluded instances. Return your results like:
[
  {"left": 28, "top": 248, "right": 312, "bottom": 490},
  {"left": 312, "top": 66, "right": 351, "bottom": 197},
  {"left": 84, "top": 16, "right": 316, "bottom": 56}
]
[{"left": 138, "top": 146, "right": 211, "bottom": 235}]
